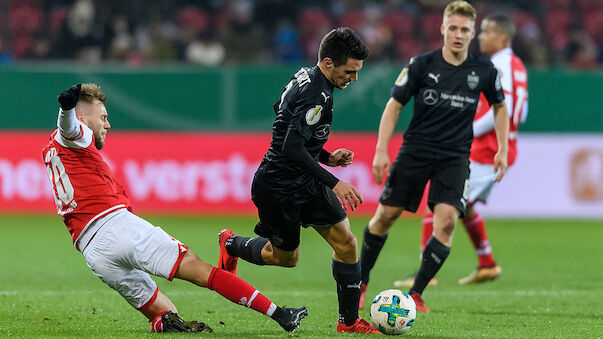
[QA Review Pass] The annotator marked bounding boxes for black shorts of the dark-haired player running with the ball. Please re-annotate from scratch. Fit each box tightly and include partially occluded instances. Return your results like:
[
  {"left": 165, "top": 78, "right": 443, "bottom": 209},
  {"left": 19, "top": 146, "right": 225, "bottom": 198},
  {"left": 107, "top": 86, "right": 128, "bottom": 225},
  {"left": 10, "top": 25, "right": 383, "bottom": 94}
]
[{"left": 251, "top": 179, "right": 347, "bottom": 251}]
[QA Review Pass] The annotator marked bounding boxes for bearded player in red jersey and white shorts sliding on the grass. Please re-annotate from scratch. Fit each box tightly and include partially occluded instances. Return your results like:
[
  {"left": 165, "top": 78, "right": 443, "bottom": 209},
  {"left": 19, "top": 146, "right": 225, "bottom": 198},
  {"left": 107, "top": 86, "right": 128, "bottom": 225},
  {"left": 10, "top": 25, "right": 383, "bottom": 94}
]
[{"left": 42, "top": 84, "right": 307, "bottom": 332}]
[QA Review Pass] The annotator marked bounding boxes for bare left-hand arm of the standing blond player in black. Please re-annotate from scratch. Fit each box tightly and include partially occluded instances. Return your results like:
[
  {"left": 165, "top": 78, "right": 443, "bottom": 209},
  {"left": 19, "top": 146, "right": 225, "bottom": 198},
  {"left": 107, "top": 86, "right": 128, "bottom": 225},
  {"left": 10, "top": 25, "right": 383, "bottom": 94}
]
[{"left": 373, "top": 98, "right": 404, "bottom": 185}]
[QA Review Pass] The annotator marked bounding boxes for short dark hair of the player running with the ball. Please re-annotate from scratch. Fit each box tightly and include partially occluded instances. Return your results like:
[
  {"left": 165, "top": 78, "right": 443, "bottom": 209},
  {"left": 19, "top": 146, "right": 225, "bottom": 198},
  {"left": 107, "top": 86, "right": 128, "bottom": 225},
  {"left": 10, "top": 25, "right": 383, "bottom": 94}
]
[{"left": 318, "top": 27, "right": 369, "bottom": 67}]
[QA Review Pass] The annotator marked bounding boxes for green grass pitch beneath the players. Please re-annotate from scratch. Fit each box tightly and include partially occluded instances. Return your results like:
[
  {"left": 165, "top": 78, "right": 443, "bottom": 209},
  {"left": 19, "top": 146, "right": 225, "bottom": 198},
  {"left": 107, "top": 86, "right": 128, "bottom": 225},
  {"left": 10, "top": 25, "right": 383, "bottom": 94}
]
[{"left": 0, "top": 215, "right": 603, "bottom": 338}]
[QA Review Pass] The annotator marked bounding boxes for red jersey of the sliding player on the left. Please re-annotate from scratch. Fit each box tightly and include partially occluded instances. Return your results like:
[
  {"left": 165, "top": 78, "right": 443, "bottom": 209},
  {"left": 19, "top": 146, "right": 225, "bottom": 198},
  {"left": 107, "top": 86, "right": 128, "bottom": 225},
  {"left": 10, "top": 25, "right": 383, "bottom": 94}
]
[{"left": 42, "top": 124, "right": 131, "bottom": 250}]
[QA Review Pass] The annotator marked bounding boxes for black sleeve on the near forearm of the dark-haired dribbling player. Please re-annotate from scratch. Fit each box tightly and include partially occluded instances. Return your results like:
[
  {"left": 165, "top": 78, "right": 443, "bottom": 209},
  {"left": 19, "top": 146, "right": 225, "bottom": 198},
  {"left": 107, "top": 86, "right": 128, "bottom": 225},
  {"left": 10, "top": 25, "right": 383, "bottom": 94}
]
[{"left": 283, "top": 129, "right": 339, "bottom": 189}]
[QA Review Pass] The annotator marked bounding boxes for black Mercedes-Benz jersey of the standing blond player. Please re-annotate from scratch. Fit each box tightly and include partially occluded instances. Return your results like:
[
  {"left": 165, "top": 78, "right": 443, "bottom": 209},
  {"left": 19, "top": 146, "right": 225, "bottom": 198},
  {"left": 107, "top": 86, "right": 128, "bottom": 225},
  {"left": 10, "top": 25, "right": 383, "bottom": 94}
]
[{"left": 391, "top": 49, "right": 505, "bottom": 158}]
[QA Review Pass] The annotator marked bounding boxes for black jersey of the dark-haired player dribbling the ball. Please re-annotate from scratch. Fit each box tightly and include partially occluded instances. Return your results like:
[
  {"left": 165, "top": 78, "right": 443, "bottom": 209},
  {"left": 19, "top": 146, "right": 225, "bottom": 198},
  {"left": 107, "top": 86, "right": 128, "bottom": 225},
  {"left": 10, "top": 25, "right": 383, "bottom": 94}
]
[{"left": 255, "top": 66, "right": 333, "bottom": 199}]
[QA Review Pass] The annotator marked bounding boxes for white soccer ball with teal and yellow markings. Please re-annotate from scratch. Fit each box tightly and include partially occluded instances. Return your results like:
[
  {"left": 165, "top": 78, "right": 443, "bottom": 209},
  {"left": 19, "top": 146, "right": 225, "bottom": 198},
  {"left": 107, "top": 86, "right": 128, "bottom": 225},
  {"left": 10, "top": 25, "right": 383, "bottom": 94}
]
[{"left": 370, "top": 290, "right": 417, "bottom": 334}]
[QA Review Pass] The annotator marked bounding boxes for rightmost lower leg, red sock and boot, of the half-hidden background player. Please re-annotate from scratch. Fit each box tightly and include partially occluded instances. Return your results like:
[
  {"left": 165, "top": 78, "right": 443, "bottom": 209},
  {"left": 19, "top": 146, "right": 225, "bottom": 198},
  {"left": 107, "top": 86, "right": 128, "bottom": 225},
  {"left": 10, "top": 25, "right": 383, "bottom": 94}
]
[{"left": 459, "top": 214, "right": 502, "bottom": 285}]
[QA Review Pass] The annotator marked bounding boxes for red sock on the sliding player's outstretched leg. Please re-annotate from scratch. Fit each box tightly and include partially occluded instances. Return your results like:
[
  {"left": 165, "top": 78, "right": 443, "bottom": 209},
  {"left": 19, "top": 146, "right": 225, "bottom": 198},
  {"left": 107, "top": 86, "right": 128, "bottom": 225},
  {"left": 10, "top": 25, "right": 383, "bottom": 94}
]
[{"left": 207, "top": 267, "right": 276, "bottom": 316}]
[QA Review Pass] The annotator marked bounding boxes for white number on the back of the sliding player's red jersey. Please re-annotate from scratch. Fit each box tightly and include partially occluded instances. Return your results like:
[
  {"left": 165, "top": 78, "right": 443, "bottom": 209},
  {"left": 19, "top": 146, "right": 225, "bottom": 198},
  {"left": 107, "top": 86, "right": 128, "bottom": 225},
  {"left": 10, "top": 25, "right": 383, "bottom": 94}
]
[{"left": 45, "top": 148, "right": 77, "bottom": 215}]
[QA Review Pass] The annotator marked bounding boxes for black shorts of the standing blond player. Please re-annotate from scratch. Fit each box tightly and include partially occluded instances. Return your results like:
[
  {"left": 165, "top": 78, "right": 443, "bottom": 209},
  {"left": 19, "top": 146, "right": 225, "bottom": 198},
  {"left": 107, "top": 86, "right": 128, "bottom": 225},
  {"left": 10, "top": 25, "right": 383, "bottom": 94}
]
[{"left": 379, "top": 152, "right": 469, "bottom": 217}]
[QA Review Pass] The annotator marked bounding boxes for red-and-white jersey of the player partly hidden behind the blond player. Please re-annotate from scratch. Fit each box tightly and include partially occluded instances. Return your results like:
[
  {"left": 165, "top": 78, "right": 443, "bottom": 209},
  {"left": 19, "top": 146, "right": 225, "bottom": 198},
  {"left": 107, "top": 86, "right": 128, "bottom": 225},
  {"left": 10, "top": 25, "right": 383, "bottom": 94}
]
[{"left": 469, "top": 48, "right": 528, "bottom": 166}]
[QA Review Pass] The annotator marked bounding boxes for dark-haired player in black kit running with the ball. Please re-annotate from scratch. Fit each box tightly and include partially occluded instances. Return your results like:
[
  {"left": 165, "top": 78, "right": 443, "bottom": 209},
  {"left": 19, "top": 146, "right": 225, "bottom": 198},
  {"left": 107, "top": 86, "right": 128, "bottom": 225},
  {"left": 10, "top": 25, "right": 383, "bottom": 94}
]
[{"left": 218, "top": 28, "right": 379, "bottom": 333}]
